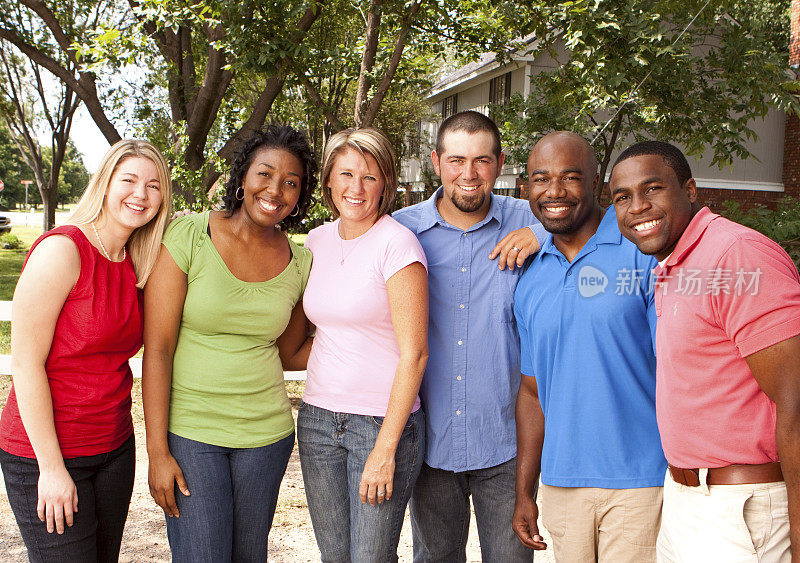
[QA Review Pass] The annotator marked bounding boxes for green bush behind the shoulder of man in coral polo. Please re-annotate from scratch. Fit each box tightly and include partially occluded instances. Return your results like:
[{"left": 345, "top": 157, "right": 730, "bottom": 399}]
[{"left": 722, "top": 196, "right": 800, "bottom": 268}]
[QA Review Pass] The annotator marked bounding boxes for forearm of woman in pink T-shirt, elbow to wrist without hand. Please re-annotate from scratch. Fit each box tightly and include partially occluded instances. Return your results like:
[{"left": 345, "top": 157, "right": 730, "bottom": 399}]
[{"left": 375, "top": 351, "right": 428, "bottom": 455}]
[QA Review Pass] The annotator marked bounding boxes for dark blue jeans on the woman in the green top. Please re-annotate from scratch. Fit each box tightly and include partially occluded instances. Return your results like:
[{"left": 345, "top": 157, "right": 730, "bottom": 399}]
[{"left": 167, "top": 432, "right": 294, "bottom": 563}]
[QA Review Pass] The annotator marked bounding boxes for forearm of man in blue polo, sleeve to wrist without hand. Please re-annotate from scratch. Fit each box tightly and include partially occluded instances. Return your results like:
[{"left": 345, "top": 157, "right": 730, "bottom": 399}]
[{"left": 515, "top": 382, "right": 544, "bottom": 497}]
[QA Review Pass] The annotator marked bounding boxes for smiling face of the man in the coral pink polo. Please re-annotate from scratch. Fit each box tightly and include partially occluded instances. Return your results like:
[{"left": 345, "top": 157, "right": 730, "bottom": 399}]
[{"left": 610, "top": 155, "right": 697, "bottom": 261}]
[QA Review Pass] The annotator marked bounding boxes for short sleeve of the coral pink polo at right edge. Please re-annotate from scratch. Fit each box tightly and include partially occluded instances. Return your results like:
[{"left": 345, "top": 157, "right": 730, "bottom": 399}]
[{"left": 712, "top": 237, "right": 800, "bottom": 357}]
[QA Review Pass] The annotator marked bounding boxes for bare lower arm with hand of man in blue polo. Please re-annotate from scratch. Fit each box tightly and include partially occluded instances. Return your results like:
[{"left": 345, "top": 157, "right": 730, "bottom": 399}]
[{"left": 511, "top": 375, "right": 547, "bottom": 549}]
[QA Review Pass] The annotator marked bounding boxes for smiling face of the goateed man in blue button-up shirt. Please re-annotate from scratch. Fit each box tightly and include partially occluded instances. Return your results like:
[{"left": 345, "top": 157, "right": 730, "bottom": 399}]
[{"left": 431, "top": 130, "right": 505, "bottom": 220}]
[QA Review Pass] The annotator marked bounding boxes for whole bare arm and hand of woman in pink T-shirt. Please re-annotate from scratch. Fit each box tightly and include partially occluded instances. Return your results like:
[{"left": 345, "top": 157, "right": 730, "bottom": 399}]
[{"left": 358, "top": 262, "right": 428, "bottom": 504}]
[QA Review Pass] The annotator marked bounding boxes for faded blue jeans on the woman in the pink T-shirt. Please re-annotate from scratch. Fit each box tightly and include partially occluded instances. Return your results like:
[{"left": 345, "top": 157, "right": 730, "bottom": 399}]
[{"left": 297, "top": 403, "right": 425, "bottom": 563}]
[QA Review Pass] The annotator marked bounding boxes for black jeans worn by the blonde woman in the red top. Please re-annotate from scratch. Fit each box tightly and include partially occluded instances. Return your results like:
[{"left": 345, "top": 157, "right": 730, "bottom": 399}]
[{"left": 0, "top": 436, "right": 136, "bottom": 563}]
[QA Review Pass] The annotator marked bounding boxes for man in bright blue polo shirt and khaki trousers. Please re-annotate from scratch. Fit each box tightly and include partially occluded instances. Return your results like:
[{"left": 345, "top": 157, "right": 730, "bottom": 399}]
[{"left": 513, "top": 132, "right": 666, "bottom": 563}]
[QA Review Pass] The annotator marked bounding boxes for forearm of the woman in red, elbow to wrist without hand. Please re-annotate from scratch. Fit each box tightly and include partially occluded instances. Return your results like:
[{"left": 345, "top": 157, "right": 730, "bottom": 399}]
[{"left": 11, "top": 365, "right": 64, "bottom": 470}]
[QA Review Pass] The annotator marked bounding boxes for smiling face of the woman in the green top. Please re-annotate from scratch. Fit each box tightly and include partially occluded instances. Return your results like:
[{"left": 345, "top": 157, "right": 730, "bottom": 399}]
[{"left": 240, "top": 147, "right": 303, "bottom": 227}]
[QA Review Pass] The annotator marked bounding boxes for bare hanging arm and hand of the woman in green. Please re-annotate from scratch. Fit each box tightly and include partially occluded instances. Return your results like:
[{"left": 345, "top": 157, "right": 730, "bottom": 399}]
[{"left": 142, "top": 246, "right": 189, "bottom": 516}]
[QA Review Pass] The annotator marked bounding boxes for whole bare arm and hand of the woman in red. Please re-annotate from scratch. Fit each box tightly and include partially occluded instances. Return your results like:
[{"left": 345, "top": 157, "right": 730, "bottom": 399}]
[{"left": 11, "top": 236, "right": 81, "bottom": 534}]
